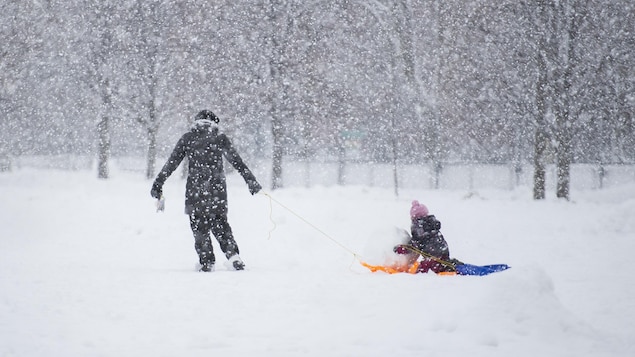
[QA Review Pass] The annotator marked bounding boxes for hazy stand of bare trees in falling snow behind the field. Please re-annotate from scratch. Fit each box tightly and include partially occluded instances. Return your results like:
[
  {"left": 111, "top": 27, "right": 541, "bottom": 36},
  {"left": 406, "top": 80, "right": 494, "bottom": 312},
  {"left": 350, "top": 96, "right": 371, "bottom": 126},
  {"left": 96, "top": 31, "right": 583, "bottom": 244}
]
[{"left": 0, "top": 0, "right": 635, "bottom": 192}]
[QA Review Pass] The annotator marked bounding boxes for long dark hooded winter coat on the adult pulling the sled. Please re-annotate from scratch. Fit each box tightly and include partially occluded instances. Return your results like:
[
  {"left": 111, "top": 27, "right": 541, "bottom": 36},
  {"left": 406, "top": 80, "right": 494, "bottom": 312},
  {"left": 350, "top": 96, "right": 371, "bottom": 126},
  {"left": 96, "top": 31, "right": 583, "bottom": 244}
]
[{"left": 155, "top": 123, "right": 260, "bottom": 214}]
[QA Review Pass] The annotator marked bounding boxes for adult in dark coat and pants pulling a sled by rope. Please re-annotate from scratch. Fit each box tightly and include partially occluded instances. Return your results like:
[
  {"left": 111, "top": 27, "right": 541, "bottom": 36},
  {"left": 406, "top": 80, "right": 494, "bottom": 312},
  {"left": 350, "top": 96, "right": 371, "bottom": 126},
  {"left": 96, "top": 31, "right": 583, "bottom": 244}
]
[{"left": 150, "top": 110, "right": 262, "bottom": 271}]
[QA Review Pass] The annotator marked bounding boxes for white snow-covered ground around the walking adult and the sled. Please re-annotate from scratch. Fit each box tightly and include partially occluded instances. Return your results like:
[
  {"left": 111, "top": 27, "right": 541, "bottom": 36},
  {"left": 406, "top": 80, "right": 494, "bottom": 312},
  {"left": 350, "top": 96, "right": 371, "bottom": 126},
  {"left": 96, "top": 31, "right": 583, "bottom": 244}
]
[{"left": 0, "top": 168, "right": 635, "bottom": 357}]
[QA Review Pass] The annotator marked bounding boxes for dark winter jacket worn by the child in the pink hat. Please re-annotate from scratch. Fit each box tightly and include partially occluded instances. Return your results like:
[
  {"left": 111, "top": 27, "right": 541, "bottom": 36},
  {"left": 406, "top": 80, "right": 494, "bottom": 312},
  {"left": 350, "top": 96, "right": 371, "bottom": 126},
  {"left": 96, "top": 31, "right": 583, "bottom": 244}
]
[{"left": 408, "top": 215, "right": 450, "bottom": 260}]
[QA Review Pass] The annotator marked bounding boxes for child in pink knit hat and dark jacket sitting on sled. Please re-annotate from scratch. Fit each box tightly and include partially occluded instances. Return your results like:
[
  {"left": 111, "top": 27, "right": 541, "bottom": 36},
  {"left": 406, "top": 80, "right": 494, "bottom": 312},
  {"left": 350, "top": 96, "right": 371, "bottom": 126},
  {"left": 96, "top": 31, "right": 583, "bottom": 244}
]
[{"left": 393, "top": 200, "right": 463, "bottom": 274}]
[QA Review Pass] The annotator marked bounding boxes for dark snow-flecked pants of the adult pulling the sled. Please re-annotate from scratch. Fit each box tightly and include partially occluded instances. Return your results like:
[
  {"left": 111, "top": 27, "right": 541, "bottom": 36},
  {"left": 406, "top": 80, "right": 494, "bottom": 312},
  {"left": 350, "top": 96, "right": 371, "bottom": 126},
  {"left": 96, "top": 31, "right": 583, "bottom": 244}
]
[{"left": 190, "top": 203, "right": 239, "bottom": 264}]
